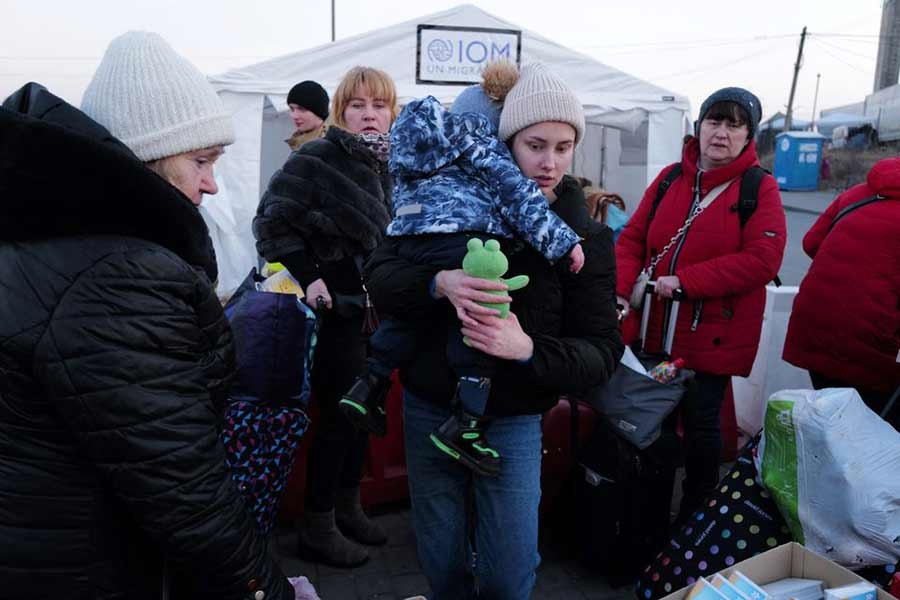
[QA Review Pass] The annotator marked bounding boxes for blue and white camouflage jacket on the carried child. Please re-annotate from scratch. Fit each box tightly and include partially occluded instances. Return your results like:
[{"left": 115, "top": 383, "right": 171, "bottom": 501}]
[{"left": 387, "top": 96, "right": 579, "bottom": 261}]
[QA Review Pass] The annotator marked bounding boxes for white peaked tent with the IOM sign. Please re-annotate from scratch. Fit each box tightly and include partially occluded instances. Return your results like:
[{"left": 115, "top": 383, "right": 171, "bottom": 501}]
[{"left": 204, "top": 4, "right": 690, "bottom": 293}]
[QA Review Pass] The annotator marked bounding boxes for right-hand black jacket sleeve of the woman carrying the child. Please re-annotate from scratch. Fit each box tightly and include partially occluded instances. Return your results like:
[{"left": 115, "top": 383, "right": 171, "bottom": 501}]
[{"left": 530, "top": 226, "right": 625, "bottom": 392}]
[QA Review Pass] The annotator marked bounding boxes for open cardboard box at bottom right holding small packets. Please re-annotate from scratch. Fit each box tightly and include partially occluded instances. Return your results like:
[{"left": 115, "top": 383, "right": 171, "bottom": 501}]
[{"left": 662, "top": 542, "right": 898, "bottom": 600}]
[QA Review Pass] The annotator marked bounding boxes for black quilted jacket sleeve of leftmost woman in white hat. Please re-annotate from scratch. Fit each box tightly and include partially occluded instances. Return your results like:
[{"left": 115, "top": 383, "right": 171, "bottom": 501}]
[{"left": 34, "top": 246, "right": 294, "bottom": 600}]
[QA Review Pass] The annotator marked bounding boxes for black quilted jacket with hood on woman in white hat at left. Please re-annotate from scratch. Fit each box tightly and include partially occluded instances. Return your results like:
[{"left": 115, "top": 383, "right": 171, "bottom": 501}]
[{"left": 0, "top": 85, "right": 293, "bottom": 600}]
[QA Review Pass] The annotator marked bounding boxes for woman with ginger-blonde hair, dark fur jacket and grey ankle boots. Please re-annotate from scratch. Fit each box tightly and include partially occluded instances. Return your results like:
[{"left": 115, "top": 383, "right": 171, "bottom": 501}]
[{"left": 253, "top": 67, "right": 398, "bottom": 567}]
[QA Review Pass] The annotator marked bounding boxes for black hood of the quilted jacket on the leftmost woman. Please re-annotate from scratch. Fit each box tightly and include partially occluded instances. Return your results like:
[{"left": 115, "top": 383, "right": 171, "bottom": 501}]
[{"left": 0, "top": 83, "right": 217, "bottom": 281}]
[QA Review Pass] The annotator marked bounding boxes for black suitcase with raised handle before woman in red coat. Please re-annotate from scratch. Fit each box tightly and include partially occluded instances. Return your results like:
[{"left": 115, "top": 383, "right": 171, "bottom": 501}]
[{"left": 574, "top": 284, "right": 681, "bottom": 586}]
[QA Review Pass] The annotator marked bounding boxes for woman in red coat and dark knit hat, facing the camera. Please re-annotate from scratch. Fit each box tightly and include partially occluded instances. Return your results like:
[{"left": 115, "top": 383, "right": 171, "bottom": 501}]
[{"left": 616, "top": 88, "right": 786, "bottom": 522}]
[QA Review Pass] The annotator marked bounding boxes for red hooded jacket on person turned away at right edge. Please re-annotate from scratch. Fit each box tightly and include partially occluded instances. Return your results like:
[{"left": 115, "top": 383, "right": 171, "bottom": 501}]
[{"left": 784, "top": 158, "right": 900, "bottom": 392}]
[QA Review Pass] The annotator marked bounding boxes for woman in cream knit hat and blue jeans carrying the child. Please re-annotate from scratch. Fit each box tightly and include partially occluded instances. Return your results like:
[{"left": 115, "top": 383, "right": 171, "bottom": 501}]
[{"left": 367, "top": 64, "right": 623, "bottom": 600}]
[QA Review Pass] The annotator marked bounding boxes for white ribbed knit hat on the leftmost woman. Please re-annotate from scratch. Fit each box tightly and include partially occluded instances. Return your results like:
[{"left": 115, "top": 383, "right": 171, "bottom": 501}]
[{"left": 81, "top": 31, "right": 234, "bottom": 162}]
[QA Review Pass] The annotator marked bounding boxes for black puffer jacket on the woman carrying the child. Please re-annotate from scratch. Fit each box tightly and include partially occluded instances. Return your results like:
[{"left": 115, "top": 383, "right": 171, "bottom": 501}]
[{"left": 366, "top": 177, "right": 624, "bottom": 416}]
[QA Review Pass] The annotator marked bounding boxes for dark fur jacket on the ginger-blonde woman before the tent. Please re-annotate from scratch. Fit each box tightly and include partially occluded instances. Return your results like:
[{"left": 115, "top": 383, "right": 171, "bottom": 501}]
[{"left": 253, "top": 127, "right": 392, "bottom": 294}]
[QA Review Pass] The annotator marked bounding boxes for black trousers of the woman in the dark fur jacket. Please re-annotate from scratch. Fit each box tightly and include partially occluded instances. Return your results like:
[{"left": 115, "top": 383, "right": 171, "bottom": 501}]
[{"left": 305, "top": 312, "right": 369, "bottom": 512}]
